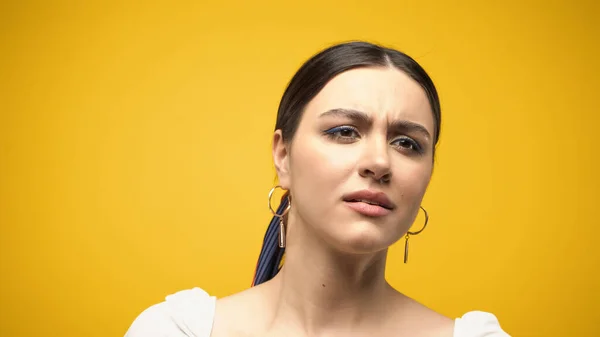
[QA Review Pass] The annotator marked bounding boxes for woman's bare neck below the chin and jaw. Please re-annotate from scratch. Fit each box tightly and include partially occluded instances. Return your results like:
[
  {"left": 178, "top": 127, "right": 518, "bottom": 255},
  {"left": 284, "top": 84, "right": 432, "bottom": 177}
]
[{"left": 262, "top": 215, "right": 393, "bottom": 336}]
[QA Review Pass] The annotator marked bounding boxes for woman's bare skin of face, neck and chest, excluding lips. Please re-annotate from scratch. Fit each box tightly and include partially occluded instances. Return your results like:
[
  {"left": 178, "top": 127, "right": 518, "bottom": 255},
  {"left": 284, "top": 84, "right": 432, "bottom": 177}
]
[{"left": 211, "top": 67, "right": 454, "bottom": 337}]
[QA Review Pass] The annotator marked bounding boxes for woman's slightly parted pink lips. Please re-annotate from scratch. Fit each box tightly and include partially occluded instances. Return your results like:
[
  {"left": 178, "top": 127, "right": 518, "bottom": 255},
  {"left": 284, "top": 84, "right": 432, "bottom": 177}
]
[{"left": 343, "top": 190, "right": 396, "bottom": 217}]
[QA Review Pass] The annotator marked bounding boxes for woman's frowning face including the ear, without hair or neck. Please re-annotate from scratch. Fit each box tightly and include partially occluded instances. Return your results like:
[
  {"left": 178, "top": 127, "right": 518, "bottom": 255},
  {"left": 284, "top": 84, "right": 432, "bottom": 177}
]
[{"left": 273, "top": 67, "right": 434, "bottom": 253}]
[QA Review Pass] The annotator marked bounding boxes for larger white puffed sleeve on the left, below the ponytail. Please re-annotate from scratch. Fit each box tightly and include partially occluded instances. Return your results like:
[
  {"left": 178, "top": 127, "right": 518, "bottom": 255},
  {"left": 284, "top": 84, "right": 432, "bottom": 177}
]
[{"left": 125, "top": 288, "right": 216, "bottom": 337}]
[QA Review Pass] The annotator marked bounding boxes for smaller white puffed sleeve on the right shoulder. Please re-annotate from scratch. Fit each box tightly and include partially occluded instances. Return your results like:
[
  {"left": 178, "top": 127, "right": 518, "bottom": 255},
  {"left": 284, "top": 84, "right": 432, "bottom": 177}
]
[{"left": 454, "top": 311, "right": 510, "bottom": 337}]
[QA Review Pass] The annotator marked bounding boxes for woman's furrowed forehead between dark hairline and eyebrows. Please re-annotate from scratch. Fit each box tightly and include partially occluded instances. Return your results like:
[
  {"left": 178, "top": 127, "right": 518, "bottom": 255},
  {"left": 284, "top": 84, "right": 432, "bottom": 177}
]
[{"left": 305, "top": 67, "right": 433, "bottom": 129}]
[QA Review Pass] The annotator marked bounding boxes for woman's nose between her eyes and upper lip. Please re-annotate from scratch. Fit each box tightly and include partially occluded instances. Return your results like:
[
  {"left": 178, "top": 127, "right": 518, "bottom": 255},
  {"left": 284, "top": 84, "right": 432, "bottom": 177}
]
[{"left": 359, "top": 139, "right": 392, "bottom": 183}]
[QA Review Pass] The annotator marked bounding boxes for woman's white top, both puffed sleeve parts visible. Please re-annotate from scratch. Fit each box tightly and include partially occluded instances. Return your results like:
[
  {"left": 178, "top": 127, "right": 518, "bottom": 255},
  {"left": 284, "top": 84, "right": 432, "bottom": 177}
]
[{"left": 125, "top": 288, "right": 510, "bottom": 337}]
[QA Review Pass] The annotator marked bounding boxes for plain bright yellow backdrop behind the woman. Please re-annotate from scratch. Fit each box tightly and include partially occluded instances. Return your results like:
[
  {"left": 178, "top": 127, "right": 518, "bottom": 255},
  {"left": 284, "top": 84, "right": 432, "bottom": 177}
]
[{"left": 0, "top": 0, "right": 600, "bottom": 337}]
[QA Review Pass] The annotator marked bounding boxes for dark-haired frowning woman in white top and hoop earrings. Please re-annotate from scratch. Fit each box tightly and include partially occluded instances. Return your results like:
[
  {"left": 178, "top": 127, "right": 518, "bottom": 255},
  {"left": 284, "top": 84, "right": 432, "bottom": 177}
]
[{"left": 126, "top": 42, "right": 508, "bottom": 337}]
